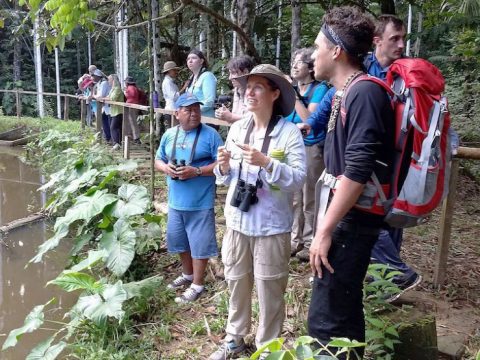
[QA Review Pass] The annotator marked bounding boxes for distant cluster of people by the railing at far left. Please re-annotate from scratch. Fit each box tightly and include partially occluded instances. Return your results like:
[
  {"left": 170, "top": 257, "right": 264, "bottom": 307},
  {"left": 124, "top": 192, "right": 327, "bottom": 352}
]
[{"left": 78, "top": 65, "right": 141, "bottom": 150}]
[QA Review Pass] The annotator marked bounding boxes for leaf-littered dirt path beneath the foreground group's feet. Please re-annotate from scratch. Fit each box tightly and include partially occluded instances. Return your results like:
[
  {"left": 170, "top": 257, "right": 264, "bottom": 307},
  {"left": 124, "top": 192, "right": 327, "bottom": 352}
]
[{"left": 149, "top": 176, "right": 480, "bottom": 359}]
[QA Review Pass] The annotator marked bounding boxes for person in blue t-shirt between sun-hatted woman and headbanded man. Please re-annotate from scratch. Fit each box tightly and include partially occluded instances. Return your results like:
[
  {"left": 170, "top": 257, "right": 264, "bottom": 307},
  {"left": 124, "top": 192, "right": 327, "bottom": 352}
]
[{"left": 285, "top": 48, "right": 328, "bottom": 261}]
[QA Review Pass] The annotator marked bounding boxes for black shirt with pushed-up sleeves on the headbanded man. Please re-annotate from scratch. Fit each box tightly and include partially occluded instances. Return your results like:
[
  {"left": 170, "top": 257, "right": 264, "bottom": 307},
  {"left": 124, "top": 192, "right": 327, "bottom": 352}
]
[{"left": 324, "top": 81, "right": 395, "bottom": 226}]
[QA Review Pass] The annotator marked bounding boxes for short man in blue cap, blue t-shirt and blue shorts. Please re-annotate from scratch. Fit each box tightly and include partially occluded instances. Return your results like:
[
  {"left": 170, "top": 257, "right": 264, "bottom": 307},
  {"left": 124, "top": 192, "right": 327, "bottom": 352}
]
[{"left": 155, "top": 93, "right": 222, "bottom": 303}]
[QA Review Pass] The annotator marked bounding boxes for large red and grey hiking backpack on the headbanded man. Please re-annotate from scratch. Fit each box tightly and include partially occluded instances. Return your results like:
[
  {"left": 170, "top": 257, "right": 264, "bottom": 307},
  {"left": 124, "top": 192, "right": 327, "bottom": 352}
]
[{"left": 340, "top": 58, "right": 451, "bottom": 228}]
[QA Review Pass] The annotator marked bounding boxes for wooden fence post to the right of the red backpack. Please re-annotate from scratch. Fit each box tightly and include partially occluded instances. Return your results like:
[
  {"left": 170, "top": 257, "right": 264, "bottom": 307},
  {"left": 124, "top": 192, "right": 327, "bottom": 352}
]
[{"left": 433, "top": 158, "right": 460, "bottom": 286}]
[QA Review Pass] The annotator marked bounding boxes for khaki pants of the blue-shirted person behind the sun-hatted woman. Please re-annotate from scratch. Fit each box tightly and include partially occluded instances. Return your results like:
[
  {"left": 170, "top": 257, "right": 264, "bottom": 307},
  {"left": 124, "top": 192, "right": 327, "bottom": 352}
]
[{"left": 292, "top": 144, "right": 325, "bottom": 249}]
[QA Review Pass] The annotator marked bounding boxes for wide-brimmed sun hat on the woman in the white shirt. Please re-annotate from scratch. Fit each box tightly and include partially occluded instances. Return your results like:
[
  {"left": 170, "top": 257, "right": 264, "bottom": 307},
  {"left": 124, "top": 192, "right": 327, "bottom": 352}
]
[{"left": 235, "top": 64, "right": 296, "bottom": 116}]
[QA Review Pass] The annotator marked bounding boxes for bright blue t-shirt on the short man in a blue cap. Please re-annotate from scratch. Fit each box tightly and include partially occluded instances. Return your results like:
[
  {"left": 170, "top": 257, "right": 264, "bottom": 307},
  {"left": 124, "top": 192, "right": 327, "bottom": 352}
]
[{"left": 155, "top": 125, "right": 223, "bottom": 211}]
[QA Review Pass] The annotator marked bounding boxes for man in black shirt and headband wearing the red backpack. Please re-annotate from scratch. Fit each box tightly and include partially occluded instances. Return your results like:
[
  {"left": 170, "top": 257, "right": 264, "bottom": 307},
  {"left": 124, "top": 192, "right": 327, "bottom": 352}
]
[{"left": 308, "top": 7, "right": 394, "bottom": 358}]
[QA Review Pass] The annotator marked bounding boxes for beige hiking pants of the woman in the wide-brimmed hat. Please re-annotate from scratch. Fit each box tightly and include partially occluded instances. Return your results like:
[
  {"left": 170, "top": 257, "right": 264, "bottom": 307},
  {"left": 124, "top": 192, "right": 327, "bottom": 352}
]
[{"left": 222, "top": 229, "right": 290, "bottom": 347}]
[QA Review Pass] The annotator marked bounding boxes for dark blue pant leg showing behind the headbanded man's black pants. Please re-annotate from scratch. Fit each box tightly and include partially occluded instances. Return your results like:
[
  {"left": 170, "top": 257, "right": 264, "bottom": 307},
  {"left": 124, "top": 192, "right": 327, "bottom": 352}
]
[{"left": 371, "top": 228, "right": 415, "bottom": 278}]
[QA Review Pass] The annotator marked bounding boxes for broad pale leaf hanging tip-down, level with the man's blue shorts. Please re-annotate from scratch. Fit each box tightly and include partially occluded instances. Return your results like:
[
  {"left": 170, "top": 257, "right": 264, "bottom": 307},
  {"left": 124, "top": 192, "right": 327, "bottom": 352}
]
[{"left": 100, "top": 219, "right": 136, "bottom": 276}]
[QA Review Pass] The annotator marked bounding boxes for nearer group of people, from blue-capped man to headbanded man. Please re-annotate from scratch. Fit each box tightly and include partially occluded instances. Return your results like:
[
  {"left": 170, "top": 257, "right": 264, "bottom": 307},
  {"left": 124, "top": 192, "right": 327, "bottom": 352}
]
[{"left": 155, "top": 7, "right": 421, "bottom": 360}]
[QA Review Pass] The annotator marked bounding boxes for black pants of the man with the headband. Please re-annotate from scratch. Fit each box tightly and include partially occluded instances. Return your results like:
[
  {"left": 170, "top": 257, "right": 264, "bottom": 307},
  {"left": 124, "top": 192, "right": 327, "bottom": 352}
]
[{"left": 308, "top": 223, "right": 380, "bottom": 355}]
